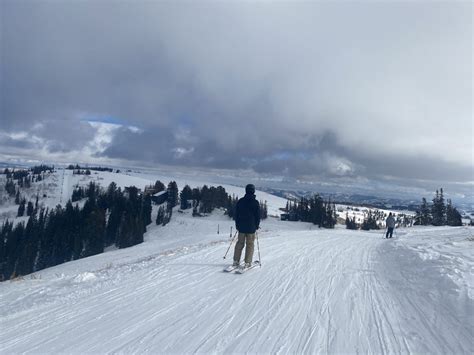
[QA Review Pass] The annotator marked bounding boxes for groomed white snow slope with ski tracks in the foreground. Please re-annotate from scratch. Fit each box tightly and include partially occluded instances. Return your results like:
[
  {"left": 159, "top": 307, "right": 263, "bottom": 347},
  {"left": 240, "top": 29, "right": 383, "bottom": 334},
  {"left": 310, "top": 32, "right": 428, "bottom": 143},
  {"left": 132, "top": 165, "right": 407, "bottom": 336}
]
[{"left": 0, "top": 222, "right": 474, "bottom": 354}]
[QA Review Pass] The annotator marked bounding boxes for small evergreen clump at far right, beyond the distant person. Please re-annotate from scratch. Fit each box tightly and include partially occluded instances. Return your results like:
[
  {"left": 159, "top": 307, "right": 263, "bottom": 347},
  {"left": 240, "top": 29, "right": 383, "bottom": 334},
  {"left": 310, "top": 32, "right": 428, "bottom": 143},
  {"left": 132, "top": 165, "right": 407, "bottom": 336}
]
[{"left": 415, "top": 188, "right": 462, "bottom": 226}]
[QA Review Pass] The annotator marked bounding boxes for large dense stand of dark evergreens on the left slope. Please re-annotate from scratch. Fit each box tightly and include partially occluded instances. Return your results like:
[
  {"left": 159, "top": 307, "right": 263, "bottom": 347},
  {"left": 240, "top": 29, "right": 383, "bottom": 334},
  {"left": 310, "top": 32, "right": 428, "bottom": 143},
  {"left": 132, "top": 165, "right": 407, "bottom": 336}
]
[{"left": 0, "top": 182, "right": 152, "bottom": 280}]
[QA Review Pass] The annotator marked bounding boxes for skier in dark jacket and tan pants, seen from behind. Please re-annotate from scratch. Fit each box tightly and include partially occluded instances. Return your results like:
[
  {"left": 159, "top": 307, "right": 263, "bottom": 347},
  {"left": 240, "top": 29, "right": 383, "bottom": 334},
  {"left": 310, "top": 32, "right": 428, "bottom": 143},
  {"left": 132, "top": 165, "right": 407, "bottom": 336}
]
[{"left": 233, "top": 184, "right": 260, "bottom": 267}]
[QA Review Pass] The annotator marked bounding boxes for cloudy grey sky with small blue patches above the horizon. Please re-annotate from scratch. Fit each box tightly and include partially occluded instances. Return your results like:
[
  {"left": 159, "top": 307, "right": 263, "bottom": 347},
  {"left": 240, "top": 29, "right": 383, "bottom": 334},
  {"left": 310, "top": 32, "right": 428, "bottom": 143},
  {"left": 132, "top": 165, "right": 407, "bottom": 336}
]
[{"left": 0, "top": 0, "right": 474, "bottom": 203}]
